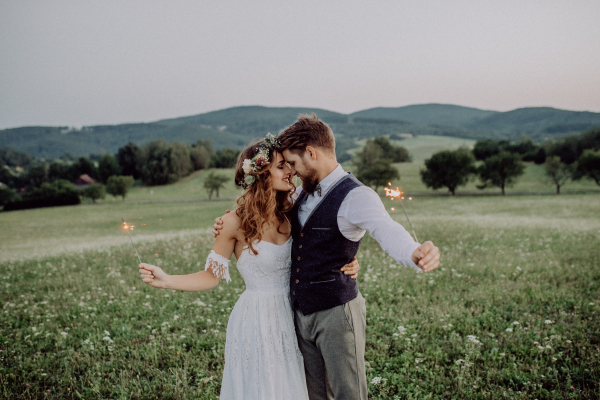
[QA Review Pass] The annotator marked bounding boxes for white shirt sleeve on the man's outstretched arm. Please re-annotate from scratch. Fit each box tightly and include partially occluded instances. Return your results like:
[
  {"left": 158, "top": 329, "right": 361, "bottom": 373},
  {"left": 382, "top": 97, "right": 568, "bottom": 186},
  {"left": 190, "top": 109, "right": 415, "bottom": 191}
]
[{"left": 337, "top": 186, "right": 421, "bottom": 271}]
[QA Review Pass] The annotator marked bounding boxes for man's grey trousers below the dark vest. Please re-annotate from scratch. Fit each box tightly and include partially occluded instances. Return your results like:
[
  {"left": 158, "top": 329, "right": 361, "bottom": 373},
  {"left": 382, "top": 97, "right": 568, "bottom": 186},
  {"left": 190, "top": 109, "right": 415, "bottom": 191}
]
[{"left": 294, "top": 293, "right": 367, "bottom": 400}]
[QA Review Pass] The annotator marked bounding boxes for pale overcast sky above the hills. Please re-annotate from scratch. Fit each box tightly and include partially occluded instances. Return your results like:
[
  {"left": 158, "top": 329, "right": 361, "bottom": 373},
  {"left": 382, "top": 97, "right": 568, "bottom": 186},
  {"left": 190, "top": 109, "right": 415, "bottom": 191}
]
[{"left": 0, "top": 0, "right": 600, "bottom": 128}]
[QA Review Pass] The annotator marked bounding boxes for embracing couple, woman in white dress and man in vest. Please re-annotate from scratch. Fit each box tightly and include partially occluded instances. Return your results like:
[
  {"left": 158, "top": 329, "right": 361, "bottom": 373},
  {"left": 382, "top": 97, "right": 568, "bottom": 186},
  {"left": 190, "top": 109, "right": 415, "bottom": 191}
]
[{"left": 140, "top": 114, "right": 440, "bottom": 400}]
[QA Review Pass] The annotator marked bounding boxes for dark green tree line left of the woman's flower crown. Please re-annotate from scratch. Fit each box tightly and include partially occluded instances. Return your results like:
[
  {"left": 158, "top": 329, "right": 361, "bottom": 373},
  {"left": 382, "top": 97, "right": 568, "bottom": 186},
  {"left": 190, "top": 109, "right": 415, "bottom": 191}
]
[{"left": 0, "top": 139, "right": 239, "bottom": 211}]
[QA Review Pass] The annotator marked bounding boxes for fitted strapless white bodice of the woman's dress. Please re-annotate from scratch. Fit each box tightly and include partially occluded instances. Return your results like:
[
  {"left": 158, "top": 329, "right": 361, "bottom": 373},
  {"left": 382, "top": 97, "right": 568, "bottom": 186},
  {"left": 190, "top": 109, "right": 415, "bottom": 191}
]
[{"left": 237, "top": 236, "right": 292, "bottom": 293}]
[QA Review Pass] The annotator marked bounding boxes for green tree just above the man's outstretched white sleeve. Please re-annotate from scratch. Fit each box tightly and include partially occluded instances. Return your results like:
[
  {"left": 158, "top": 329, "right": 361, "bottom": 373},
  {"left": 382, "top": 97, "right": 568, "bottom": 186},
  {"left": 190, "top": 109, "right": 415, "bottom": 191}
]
[{"left": 352, "top": 140, "right": 400, "bottom": 191}]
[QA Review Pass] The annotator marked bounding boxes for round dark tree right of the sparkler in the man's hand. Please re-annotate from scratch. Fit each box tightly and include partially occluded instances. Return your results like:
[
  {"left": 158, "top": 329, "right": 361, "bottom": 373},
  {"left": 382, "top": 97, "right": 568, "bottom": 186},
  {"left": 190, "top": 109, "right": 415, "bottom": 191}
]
[{"left": 421, "top": 148, "right": 476, "bottom": 196}]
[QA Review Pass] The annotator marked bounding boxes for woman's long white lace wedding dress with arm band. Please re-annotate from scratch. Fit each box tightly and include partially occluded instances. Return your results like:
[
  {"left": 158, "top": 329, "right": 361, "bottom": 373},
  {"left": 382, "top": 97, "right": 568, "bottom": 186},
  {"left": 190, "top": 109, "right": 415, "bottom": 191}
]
[{"left": 207, "top": 237, "right": 308, "bottom": 400}]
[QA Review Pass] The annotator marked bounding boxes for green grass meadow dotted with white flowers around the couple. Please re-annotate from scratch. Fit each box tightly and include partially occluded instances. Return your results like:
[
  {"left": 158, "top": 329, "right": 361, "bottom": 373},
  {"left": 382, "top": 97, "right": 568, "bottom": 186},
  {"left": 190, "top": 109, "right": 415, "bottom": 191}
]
[{"left": 0, "top": 194, "right": 600, "bottom": 399}]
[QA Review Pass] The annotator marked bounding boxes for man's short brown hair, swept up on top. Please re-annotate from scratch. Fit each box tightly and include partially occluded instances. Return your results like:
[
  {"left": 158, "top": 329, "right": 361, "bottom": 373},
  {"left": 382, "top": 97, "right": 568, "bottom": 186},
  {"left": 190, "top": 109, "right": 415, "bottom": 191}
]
[{"left": 278, "top": 113, "right": 335, "bottom": 154}]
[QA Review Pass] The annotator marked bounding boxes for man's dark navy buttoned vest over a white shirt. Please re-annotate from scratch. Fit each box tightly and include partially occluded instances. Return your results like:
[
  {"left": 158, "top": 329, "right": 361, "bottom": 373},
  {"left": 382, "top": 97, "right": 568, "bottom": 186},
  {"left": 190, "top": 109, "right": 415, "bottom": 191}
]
[{"left": 290, "top": 174, "right": 362, "bottom": 315}]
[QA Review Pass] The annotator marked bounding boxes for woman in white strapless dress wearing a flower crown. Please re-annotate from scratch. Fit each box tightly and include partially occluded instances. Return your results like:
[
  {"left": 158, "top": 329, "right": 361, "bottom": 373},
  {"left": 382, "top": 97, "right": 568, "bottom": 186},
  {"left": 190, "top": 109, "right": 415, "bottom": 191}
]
[{"left": 139, "top": 134, "right": 359, "bottom": 400}]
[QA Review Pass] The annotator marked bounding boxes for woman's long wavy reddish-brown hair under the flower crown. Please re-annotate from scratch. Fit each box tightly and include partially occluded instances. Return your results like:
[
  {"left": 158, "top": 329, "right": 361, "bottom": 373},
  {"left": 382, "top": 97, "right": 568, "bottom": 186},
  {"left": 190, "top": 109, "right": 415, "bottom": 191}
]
[{"left": 235, "top": 140, "right": 296, "bottom": 255}]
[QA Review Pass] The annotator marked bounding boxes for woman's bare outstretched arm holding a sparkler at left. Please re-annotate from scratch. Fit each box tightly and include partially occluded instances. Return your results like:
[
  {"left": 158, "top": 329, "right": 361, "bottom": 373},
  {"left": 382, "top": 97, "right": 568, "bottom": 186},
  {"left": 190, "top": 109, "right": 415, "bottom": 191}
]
[{"left": 140, "top": 213, "right": 239, "bottom": 292}]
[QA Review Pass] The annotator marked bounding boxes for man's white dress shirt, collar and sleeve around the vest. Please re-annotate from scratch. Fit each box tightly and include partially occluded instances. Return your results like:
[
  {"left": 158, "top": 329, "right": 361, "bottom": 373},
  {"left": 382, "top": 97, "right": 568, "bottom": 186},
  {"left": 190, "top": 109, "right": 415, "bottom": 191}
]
[{"left": 294, "top": 164, "right": 421, "bottom": 271}]
